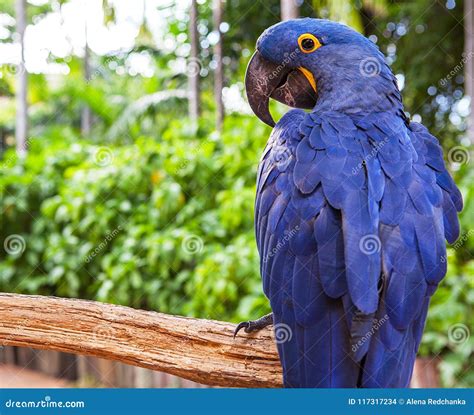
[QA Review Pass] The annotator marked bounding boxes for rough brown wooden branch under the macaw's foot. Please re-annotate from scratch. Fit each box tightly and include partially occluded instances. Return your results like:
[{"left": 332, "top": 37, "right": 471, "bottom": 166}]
[{"left": 0, "top": 293, "right": 282, "bottom": 387}]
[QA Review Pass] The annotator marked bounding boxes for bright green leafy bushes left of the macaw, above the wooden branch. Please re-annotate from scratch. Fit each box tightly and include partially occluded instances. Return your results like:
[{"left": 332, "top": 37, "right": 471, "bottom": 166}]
[{"left": 0, "top": 117, "right": 268, "bottom": 320}]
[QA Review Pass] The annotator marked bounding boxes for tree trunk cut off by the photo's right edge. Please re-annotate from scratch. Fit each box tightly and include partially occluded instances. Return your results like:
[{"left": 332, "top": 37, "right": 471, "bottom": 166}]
[{"left": 464, "top": 0, "right": 474, "bottom": 144}]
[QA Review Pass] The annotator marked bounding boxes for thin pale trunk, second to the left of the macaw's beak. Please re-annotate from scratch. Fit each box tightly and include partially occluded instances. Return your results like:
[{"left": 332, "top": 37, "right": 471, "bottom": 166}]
[{"left": 187, "top": 0, "right": 201, "bottom": 123}]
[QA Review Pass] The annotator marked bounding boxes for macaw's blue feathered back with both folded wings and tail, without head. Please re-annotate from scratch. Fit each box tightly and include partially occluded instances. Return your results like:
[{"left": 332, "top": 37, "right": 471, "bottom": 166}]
[{"left": 256, "top": 110, "right": 462, "bottom": 387}]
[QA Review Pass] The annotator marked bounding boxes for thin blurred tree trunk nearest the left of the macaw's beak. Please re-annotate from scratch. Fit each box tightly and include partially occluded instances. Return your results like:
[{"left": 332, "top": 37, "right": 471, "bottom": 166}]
[{"left": 212, "top": 0, "right": 224, "bottom": 131}]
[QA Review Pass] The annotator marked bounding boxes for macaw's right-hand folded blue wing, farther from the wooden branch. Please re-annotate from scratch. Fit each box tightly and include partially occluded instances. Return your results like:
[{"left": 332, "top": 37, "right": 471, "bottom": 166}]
[{"left": 362, "top": 117, "right": 462, "bottom": 387}]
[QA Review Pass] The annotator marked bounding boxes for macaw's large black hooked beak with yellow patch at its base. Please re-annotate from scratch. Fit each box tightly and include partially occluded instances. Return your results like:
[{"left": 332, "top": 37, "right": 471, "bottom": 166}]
[{"left": 245, "top": 51, "right": 317, "bottom": 127}]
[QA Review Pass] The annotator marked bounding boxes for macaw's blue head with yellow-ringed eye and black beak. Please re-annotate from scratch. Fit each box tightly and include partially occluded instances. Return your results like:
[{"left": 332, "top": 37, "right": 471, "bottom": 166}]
[{"left": 245, "top": 18, "right": 390, "bottom": 126}]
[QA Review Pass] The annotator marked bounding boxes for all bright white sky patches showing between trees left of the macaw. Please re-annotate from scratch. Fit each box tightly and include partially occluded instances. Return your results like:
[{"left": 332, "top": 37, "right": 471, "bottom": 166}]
[{"left": 0, "top": 0, "right": 251, "bottom": 113}]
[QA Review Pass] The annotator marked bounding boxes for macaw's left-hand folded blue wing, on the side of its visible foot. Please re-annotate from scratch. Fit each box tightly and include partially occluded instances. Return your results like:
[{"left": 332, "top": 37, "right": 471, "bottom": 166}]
[{"left": 255, "top": 110, "right": 380, "bottom": 387}]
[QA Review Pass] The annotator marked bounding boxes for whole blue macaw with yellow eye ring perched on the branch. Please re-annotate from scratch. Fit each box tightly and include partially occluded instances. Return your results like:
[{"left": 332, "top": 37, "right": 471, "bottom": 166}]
[{"left": 236, "top": 18, "right": 463, "bottom": 388}]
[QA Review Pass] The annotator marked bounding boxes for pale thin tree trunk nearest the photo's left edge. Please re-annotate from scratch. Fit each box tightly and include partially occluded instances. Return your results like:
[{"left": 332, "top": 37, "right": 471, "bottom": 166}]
[{"left": 15, "top": 0, "right": 28, "bottom": 157}]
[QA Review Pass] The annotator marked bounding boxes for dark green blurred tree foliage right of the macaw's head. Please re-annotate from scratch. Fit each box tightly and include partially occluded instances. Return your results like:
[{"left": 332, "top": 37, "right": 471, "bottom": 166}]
[{"left": 369, "top": 0, "right": 467, "bottom": 147}]
